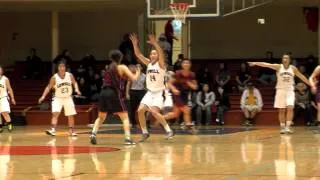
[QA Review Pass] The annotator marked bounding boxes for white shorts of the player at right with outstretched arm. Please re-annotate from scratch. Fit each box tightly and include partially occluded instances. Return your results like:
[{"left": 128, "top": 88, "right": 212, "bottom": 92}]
[{"left": 274, "top": 89, "right": 295, "bottom": 108}]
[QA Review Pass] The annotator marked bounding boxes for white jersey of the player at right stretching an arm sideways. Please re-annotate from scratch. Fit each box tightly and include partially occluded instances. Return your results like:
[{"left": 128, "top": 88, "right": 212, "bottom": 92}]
[{"left": 276, "top": 64, "right": 294, "bottom": 91}]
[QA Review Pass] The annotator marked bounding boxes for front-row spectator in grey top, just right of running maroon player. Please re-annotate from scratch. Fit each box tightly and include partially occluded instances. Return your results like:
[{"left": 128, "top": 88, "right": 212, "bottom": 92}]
[{"left": 196, "top": 84, "right": 216, "bottom": 125}]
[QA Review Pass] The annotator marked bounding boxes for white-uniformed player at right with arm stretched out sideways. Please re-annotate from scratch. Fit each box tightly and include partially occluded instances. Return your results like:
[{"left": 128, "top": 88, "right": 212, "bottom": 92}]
[{"left": 248, "top": 54, "right": 310, "bottom": 134}]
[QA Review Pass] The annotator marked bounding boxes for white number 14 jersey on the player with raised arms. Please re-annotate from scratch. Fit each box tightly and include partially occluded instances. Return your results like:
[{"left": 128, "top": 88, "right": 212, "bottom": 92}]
[{"left": 146, "top": 62, "right": 166, "bottom": 92}]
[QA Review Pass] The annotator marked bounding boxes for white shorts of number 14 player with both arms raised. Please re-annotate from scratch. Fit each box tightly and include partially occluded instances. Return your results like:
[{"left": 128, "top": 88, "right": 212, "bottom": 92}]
[{"left": 140, "top": 91, "right": 164, "bottom": 109}]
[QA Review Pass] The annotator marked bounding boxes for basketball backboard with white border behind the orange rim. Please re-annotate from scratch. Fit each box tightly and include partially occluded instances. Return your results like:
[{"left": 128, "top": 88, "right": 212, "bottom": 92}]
[{"left": 147, "top": 0, "right": 221, "bottom": 19}]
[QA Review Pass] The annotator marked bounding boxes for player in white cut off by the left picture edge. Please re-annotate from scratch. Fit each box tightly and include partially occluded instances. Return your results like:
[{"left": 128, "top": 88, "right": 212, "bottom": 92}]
[{"left": 0, "top": 66, "right": 16, "bottom": 132}]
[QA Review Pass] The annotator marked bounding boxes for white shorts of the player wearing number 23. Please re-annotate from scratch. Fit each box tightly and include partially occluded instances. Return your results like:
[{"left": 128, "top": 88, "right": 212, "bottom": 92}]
[{"left": 52, "top": 97, "right": 77, "bottom": 116}]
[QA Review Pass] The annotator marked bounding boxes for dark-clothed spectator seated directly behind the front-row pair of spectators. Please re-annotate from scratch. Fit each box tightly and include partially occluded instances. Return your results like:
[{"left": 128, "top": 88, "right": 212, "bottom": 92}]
[{"left": 216, "top": 63, "right": 231, "bottom": 93}]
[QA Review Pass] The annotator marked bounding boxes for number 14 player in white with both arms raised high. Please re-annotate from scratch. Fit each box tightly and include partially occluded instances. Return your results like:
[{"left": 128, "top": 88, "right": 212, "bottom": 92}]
[{"left": 130, "top": 34, "right": 173, "bottom": 142}]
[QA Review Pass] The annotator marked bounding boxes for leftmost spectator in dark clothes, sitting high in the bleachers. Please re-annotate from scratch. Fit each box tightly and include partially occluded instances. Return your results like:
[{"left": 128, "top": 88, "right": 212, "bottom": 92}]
[{"left": 24, "top": 48, "right": 42, "bottom": 79}]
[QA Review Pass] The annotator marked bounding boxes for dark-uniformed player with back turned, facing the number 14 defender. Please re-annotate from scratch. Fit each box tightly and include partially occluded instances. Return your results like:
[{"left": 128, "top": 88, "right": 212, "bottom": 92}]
[{"left": 90, "top": 50, "right": 140, "bottom": 145}]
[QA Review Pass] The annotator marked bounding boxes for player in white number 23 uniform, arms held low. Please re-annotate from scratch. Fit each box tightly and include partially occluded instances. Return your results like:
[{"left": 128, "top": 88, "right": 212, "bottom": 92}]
[{"left": 39, "top": 61, "right": 81, "bottom": 136}]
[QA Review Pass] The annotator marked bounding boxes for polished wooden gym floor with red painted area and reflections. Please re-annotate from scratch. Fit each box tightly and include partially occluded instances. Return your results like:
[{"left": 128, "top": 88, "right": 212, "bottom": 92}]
[{"left": 0, "top": 126, "right": 320, "bottom": 180}]
